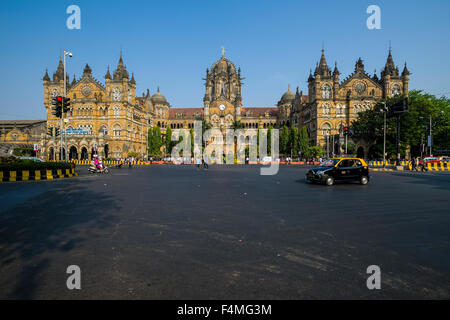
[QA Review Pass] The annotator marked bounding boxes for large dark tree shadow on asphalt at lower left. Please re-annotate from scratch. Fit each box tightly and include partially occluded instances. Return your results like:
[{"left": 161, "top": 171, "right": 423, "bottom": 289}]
[{"left": 0, "top": 180, "right": 118, "bottom": 299}]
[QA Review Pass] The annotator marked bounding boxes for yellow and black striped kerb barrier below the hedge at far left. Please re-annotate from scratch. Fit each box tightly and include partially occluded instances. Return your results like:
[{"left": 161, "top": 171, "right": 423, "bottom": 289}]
[{"left": 0, "top": 168, "right": 78, "bottom": 182}]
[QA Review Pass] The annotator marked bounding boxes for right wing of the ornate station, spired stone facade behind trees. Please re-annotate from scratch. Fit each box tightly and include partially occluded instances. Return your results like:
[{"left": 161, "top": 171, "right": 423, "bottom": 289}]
[{"left": 284, "top": 49, "right": 410, "bottom": 157}]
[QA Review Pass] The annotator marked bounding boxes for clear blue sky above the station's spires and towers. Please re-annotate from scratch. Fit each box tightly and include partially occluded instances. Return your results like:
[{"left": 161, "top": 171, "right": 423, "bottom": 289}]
[{"left": 0, "top": 0, "right": 450, "bottom": 119}]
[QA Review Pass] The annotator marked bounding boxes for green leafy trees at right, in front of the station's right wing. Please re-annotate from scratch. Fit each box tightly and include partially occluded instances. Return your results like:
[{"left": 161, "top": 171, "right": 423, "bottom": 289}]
[{"left": 351, "top": 90, "right": 450, "bottom": 158}]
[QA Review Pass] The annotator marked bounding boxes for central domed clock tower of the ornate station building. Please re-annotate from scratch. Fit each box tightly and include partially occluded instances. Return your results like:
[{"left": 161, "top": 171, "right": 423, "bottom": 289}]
[{"left": 203, "top": 48, "right": 243, "bottom": 128}]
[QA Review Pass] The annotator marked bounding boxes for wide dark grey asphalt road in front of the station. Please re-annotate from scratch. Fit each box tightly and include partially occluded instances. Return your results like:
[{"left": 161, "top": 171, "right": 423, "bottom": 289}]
[{"left": 0, "top": 165, "right": 450, "bottom": 299}]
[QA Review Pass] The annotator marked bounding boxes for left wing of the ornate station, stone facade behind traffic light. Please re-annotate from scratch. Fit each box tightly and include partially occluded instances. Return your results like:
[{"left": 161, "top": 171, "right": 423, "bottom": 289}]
[{"left": 42, "top": 55, "right": 154, "bottom": 160}]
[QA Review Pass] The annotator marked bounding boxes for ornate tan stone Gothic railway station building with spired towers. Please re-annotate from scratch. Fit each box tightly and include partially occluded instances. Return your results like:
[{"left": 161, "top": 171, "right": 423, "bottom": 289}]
[{"left": 0, "top": 49, "right": 409, "bottom": 159}]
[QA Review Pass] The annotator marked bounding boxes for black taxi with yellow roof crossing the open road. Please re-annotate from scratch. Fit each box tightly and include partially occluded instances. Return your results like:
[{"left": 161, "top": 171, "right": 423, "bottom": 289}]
[{"left": 306, "top": 158, "right": 370, "bottom": 186}]
